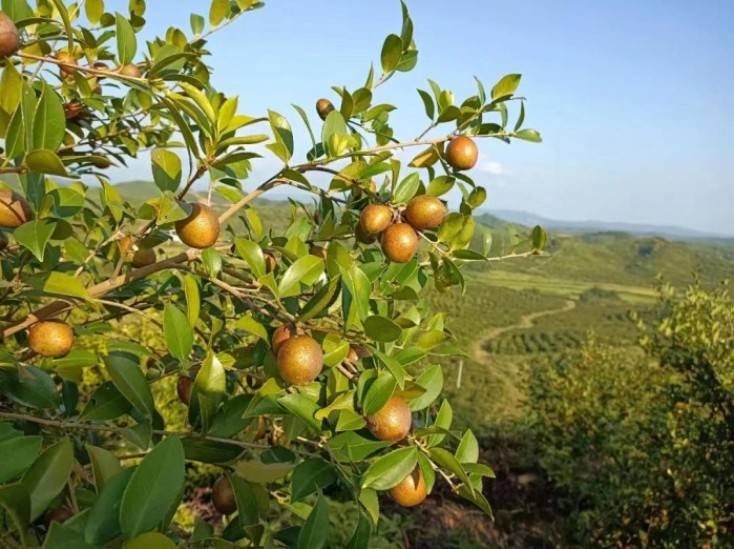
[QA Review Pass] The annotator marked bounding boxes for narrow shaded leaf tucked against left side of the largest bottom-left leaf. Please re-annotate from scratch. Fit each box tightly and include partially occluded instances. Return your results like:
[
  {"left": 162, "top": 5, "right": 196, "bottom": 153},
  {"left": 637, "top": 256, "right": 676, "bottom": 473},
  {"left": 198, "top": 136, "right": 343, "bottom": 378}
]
[{"left": 84, "top": 468, "right": 135, "bottom": 545}]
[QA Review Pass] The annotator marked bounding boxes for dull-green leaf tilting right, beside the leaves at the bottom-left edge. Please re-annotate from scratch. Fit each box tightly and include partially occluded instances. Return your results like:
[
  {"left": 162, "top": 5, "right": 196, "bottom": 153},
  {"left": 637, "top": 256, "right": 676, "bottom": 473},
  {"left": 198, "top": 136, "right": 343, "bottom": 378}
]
[{"left": 21, "top": 438, "right": 74, "bottom": 521}]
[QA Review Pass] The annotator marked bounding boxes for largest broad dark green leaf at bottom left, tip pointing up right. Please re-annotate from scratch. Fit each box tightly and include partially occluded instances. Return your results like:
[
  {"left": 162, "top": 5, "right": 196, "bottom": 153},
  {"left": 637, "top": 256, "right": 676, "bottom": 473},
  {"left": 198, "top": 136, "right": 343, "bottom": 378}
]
[{"left": 120, "top": 437, "right": 185, "bottom": 538}]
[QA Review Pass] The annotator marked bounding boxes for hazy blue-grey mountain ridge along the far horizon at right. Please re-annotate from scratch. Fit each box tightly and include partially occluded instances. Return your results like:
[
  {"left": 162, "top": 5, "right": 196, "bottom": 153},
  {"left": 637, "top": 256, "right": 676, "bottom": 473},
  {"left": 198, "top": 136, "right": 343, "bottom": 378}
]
[{"left": 488, "top": 210, "right": 734, "bottom": 240}]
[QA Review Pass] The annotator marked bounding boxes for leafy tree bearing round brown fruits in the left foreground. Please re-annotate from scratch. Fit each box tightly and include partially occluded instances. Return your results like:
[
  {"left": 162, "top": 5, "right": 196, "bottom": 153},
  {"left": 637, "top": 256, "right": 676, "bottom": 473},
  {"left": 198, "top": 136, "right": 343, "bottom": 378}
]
[{"left": 0, "top": 0, "right": 545, "bottom": 548}]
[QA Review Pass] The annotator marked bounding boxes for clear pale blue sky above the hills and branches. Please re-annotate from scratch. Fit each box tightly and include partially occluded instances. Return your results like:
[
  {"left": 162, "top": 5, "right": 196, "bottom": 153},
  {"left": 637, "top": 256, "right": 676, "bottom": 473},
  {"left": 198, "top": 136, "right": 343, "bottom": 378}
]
[{"left": 129, "top": 0, "right": 734, "bottom": 234}]
